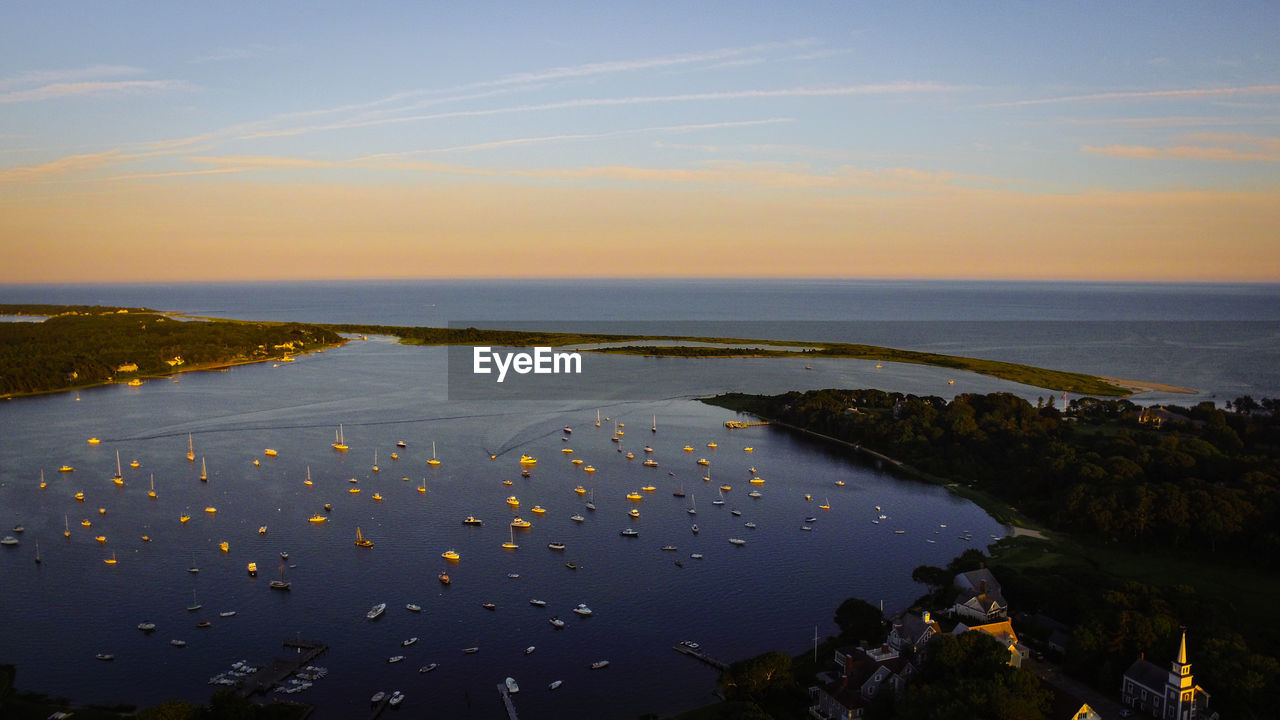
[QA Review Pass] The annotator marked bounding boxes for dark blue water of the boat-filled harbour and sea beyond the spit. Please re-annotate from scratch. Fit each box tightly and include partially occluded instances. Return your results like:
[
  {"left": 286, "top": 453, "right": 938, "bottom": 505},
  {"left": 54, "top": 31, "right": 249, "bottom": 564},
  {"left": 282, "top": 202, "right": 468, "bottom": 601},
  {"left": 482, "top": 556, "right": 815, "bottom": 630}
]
[{"left": 0, "top": 281, "right": 1280, "bottom": 720}]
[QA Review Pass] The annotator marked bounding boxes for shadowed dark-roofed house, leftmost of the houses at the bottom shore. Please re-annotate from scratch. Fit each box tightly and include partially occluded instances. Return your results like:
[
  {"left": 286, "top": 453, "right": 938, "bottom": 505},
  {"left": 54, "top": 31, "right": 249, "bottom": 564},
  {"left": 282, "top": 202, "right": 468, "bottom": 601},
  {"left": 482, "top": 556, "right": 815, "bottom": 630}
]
[{"left": 809, "top": 646, "right": 919, "bottom": 720}]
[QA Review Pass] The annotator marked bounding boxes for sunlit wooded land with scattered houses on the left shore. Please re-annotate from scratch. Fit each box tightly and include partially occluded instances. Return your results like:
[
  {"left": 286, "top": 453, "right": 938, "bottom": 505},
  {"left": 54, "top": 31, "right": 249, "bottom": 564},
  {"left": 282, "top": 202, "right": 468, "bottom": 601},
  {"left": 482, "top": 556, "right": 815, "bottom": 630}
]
[{"left": 0, "top": 312, "right": 342, "bottom": 395}]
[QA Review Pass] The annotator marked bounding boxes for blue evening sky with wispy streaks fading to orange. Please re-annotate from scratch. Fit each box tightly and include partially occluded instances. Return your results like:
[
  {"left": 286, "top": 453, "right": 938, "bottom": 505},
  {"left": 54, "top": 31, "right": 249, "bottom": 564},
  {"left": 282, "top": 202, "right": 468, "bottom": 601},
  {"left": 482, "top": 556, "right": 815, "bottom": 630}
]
[{"left": 0, "top": 0, "right": 1280, "bottom": 283}]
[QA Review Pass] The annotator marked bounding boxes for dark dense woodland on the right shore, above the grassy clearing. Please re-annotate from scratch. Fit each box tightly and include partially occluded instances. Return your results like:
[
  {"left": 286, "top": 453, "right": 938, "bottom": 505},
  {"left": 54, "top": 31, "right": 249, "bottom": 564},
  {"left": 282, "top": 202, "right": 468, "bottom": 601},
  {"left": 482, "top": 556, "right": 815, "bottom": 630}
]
[{"left": 714, "top": 389, "right": 1280, "bottom": 566}]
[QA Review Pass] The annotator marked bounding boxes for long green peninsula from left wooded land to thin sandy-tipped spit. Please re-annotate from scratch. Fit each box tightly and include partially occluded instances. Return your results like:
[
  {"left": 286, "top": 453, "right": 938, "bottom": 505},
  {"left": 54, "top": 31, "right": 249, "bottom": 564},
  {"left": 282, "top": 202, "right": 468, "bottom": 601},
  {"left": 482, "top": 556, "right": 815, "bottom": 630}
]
[{"left": 0, "top": 305, "right": 1152, "bottom": 397}]
